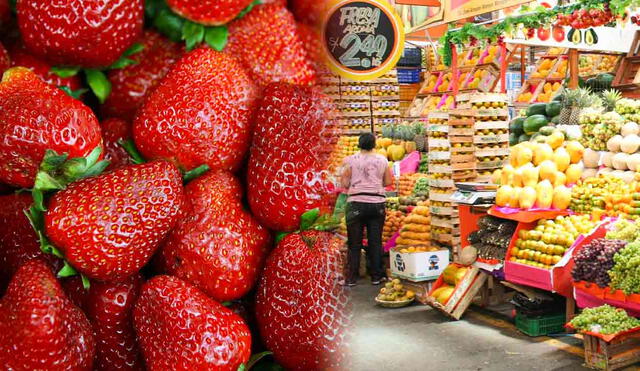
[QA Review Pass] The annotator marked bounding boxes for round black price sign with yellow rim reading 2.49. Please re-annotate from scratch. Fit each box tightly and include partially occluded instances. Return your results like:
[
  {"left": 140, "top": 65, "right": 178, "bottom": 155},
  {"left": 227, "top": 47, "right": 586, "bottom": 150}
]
[{"left": 322, "top": 0, "right": 404, "bottom": 81}]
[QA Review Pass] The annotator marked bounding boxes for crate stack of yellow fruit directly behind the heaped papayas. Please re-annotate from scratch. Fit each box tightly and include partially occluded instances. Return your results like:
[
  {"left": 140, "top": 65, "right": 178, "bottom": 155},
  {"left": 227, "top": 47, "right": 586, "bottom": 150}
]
[{"left": 469, "top": 94, "right": 509, "bottom": 182}]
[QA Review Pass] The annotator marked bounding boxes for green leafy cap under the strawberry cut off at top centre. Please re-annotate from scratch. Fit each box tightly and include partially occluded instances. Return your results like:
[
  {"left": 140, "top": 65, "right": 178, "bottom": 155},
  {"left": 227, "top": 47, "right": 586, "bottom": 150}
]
[{"left": 145, "top": 0, "right": 262, "bottom": 51}]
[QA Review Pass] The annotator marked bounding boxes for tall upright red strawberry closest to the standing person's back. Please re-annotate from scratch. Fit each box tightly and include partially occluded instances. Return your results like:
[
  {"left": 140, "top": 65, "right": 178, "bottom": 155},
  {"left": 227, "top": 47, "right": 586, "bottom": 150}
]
[{"left": 247, "top": 83, "right": 335, "bottom": 231}]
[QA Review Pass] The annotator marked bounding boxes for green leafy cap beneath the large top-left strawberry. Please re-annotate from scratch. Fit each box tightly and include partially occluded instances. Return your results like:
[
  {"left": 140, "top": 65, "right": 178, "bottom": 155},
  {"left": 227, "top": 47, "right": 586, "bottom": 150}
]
[{"left": 51, "top": 43, "right": 144, "bottom": 104}]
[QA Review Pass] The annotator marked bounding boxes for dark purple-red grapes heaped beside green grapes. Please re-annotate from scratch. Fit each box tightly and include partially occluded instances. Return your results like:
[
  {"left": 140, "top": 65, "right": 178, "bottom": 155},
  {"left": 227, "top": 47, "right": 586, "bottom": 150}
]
[{"left": 571, "top": 238, "right": 627, "bottom": 288}]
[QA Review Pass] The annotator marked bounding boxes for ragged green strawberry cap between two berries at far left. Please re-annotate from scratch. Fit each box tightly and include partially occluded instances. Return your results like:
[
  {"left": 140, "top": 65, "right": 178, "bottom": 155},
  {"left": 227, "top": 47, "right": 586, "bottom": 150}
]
[{"left": 25, "top": 146, "right": 109, "bottom": 288}]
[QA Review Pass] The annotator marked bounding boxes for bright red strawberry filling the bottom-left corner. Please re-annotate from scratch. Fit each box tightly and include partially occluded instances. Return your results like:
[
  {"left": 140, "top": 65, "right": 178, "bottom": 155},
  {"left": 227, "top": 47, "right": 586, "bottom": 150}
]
[{"left": 0, "top": 261, "right": 95, "bottom": 370}]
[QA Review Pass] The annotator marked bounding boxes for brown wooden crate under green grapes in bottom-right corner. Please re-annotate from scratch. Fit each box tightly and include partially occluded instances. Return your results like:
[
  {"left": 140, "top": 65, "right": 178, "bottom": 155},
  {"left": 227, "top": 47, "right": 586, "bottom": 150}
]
[{"left": 582, "top": 333, "right": 640, "bottom": 370}]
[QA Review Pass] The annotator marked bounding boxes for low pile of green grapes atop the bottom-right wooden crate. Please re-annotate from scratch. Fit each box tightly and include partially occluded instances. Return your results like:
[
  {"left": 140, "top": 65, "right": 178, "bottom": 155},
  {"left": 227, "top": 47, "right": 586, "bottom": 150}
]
[{"left": 571, "top": 304, "right": 640, "bottom": 335}]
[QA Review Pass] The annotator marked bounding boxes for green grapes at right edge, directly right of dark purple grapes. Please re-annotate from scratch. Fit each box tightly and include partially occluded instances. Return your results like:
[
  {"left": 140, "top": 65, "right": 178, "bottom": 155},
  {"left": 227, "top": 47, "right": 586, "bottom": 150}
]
[{"left": 609, "top": 242, "right": 640, "bottom": 295}]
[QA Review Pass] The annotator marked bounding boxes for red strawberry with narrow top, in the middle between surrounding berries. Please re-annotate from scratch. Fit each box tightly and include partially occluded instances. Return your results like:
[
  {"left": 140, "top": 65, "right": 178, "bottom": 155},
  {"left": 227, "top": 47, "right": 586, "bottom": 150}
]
[{"left": 162, "top": 172, "right": 271, "bottom": 301}]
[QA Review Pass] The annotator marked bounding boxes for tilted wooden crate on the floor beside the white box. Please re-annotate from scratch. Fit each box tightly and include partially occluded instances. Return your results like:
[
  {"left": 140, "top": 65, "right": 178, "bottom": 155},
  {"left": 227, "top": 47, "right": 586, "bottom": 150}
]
[{"left": 427, "top": 267, "right": 487, "bottom": 320}]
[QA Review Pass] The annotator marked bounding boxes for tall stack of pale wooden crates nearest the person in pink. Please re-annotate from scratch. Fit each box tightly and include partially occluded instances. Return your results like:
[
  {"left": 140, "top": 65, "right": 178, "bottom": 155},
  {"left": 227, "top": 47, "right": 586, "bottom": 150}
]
[{"left": 427, "top": 110, "right": 476, "bottom": 257}]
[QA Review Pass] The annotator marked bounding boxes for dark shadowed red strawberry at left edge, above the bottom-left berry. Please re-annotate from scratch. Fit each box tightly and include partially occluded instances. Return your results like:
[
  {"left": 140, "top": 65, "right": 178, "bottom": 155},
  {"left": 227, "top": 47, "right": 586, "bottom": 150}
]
[{"left": 0, "top": 193, "right": 61, "bottom": 292}]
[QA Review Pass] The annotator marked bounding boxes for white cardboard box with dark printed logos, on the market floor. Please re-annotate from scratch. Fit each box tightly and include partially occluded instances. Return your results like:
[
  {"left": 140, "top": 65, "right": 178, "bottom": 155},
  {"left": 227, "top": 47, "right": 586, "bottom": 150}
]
[{"left": 389, "top": 250, "right": 449, "bottom": 282}]
